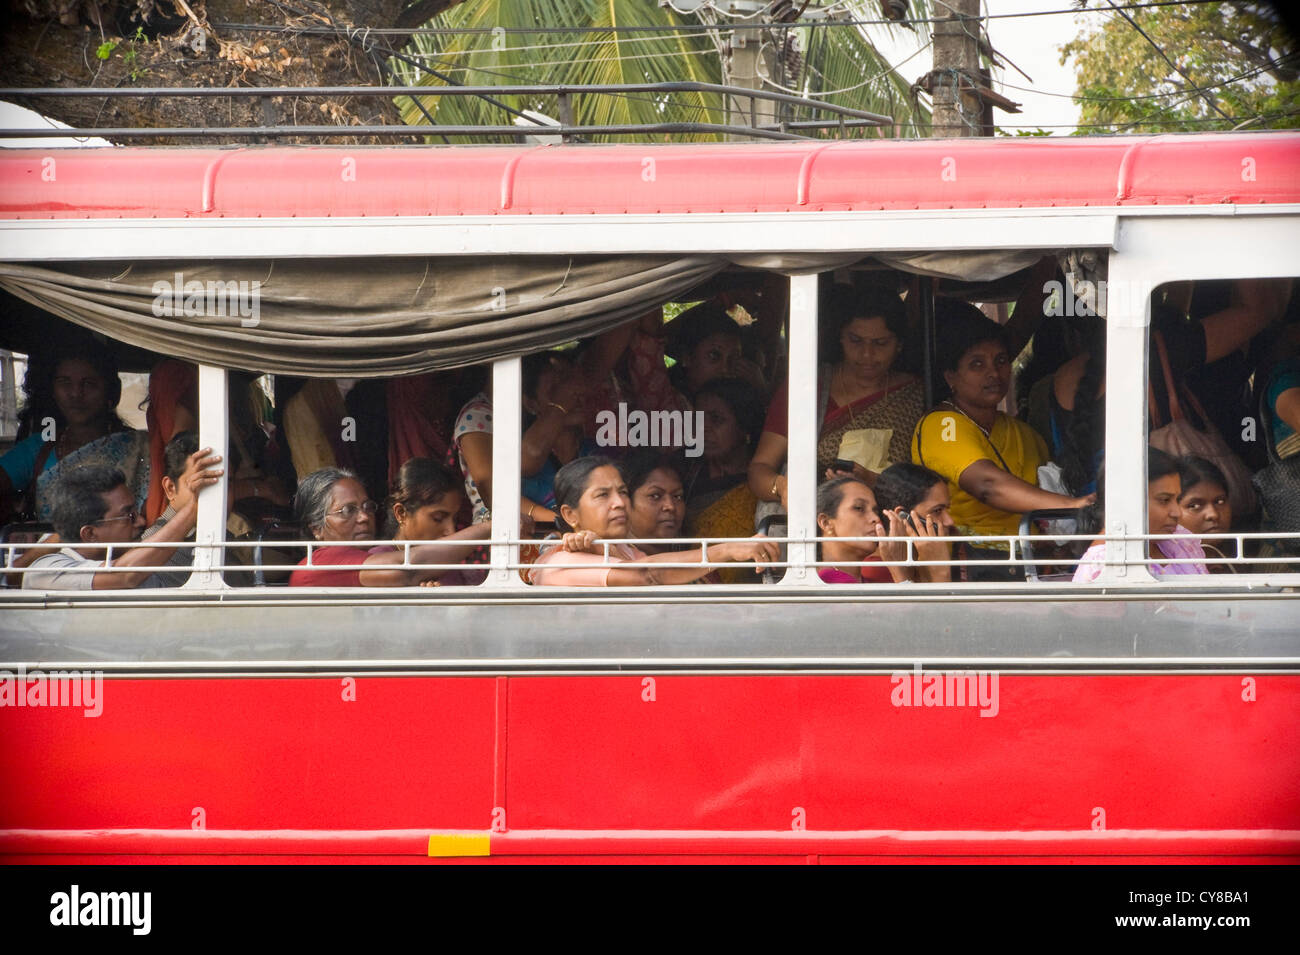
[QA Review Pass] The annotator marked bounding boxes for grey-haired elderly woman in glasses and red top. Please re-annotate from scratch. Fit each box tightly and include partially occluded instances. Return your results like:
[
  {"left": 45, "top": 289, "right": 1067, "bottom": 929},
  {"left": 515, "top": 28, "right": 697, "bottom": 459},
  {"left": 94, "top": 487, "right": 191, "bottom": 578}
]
[{"left": 289, "top": 468, "right": 491, "bottom": 587}]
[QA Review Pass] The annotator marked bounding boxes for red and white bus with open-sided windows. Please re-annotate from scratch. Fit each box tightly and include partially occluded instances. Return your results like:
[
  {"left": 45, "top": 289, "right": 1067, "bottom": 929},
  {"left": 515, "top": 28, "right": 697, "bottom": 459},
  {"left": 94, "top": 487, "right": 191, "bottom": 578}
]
[{"left": 0, "top": 133, "right": 1300, "bottom": 864}]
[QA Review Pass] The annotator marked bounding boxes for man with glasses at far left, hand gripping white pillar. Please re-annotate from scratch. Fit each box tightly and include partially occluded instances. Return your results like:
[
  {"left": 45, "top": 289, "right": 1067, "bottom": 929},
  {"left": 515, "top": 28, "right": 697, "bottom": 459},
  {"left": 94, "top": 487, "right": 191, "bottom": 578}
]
[{"left": 22, "top": 448, "right": 222, "bottom": 590}]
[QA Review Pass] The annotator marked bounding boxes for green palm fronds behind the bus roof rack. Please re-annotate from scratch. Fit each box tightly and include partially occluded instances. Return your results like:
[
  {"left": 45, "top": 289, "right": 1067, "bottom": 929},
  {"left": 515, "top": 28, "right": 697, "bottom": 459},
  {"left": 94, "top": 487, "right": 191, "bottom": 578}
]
[{"left": 397, "top": 0, "right": 930, "bottom": 142}]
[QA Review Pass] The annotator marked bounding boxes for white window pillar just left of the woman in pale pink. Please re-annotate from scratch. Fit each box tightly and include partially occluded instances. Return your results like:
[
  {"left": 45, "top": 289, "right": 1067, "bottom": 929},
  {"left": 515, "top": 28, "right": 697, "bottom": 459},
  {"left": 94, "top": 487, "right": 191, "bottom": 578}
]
[{"left": 485, "top": 357, "right": 524, "bottom": 587}]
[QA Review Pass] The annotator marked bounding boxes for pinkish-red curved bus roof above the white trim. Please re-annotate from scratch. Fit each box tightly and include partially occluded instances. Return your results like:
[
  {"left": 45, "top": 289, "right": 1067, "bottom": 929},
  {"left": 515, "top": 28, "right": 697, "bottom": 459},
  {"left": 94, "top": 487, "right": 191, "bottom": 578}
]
[{"left": 0, "top": 133, "right": 1300, "bottom": 220}]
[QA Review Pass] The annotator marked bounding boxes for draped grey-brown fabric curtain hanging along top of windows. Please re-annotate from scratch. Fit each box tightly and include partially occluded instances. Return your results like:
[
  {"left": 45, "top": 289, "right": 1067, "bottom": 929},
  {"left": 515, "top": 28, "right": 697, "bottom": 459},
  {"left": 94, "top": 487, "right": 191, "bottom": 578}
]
[{"left": 0, "top": 252, "right": 1041, "bottom": 378}]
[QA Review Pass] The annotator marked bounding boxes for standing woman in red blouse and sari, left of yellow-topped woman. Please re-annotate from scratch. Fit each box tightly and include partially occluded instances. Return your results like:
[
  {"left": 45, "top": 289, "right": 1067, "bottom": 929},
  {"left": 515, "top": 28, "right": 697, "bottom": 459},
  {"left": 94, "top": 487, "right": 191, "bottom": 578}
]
[{"left": 749, "top": 283, "right": 926, "bottom": 508}]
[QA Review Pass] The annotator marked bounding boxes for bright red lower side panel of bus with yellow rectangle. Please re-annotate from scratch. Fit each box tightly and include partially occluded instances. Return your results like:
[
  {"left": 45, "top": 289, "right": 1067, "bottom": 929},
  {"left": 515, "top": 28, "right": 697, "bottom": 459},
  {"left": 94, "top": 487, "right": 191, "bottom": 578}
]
[{"left": 0, "top": 674, "right": 1300, "bottom": 863}]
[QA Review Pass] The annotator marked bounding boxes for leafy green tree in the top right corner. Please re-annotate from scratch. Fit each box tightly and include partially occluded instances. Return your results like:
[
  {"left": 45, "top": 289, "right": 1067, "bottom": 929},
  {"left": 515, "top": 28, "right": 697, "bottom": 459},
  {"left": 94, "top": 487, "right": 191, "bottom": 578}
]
[{"left": 1061, "top": 3, "right": 1300, "bottom": 134}]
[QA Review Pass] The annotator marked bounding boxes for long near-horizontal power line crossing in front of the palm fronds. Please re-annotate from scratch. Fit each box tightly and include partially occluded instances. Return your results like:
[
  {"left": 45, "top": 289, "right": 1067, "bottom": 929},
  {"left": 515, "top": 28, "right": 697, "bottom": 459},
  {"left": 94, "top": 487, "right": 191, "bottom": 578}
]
[{"left": 212, "top": 0, "right": 1221, "bottom": 36}]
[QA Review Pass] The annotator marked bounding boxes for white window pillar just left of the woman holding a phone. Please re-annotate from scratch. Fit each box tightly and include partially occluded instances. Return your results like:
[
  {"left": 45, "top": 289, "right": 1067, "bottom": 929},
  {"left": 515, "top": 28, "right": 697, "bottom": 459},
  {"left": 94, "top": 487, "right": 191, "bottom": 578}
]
[{"left": 781, "top": 275, "right": 818, "bottom": 585}]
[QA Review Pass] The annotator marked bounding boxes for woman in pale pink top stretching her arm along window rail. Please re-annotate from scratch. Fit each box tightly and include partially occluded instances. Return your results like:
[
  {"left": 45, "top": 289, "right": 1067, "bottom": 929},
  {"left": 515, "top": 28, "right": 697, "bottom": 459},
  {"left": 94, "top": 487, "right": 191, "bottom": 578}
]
[{"left": 528, "top": 456, "right": 777, "bottom": 587}]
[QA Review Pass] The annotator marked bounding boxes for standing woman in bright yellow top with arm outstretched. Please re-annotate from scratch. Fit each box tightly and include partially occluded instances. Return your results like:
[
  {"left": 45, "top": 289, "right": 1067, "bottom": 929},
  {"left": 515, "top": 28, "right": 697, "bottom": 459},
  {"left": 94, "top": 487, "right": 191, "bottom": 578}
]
[{"left": 911, "top": 299, "right": 1093, "bottom": 579}]
